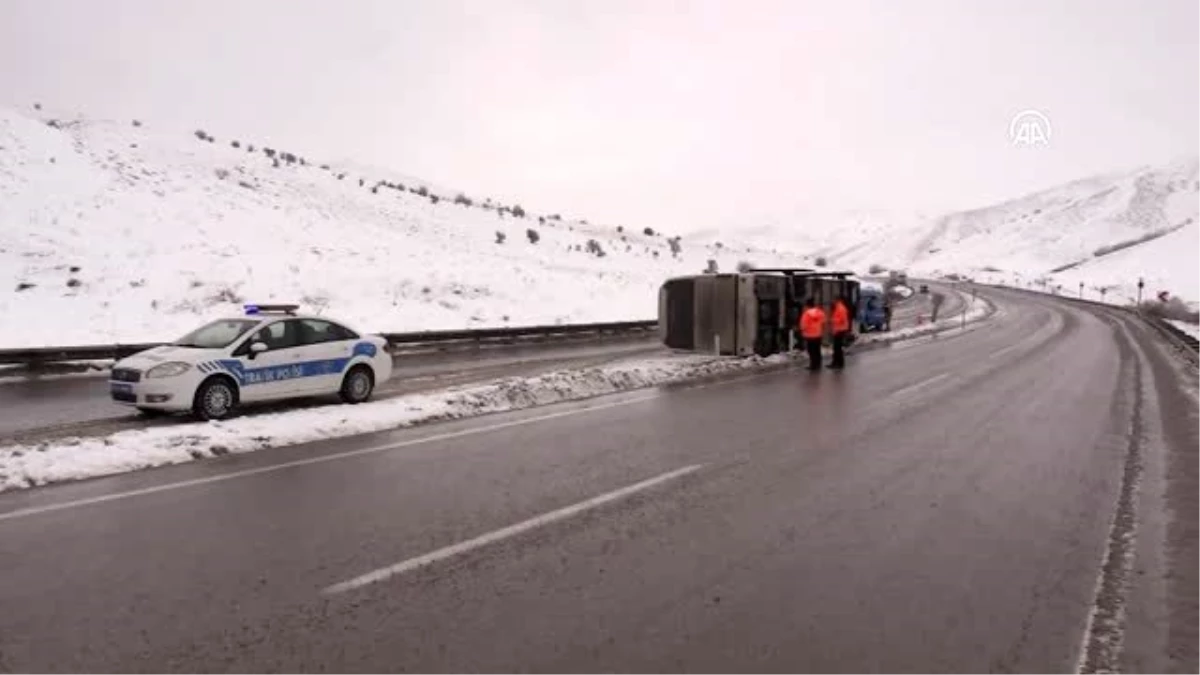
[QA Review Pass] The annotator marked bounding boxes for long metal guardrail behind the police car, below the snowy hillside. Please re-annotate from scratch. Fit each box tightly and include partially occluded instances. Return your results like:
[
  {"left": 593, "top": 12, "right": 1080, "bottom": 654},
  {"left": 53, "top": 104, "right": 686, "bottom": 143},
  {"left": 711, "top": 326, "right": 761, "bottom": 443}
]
[{"left": 0, "top": 321, "right": 658, "bottom": 366}]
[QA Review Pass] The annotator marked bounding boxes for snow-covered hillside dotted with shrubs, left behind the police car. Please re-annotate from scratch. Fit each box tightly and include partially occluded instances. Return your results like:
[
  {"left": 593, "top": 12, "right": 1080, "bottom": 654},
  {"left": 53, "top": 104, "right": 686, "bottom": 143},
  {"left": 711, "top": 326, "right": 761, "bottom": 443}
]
[{"left": 0, "top": 108, "right": 806, "bottom": 347}]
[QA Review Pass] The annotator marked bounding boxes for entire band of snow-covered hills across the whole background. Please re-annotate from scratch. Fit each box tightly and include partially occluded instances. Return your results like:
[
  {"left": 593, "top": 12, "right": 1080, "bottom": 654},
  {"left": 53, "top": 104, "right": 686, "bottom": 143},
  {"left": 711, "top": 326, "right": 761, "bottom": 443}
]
[{"left": 0, "top": 103, "right": 1200, "bottom": 347}]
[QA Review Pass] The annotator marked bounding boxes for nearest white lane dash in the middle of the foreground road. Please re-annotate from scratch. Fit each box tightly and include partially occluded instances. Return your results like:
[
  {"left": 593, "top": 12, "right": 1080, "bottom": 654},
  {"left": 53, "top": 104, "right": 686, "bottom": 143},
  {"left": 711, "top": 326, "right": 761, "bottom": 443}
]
[{"left": 322, "top": 464, "right": 704, "bottom": 595}]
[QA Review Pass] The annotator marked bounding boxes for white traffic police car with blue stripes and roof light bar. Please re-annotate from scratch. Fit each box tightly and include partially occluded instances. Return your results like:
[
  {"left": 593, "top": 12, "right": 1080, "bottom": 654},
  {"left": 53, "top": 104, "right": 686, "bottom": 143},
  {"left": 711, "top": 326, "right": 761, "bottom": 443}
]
[{"left": 109, "top": 305, "right": 392, "bottom": 419}]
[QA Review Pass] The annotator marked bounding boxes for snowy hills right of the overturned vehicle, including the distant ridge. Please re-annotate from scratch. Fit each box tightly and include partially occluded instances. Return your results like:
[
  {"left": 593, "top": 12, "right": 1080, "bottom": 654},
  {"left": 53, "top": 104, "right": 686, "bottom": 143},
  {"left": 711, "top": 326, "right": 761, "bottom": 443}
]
[{"left": 756, "top": 160, "right": 1200, "bottom": 301}]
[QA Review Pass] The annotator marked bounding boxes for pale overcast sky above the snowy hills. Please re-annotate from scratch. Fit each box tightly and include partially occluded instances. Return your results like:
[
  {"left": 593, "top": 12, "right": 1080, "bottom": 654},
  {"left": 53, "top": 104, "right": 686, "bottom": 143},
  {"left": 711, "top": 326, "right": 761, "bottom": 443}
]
[{"left": 0, "top": 0, "right": 1200, "bottom": 231}]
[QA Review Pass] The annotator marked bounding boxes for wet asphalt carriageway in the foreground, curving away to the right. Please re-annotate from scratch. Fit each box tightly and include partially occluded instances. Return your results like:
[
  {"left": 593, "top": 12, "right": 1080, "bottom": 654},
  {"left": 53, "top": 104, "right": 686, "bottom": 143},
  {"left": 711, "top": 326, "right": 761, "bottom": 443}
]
[{"left": 0, "top": 284, "right": 1200, "bottom": 675}]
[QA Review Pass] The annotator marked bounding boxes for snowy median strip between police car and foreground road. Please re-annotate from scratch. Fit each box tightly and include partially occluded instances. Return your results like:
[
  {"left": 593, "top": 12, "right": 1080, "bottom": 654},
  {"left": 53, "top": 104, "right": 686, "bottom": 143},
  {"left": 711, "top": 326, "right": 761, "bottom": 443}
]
[{"left": 0, "top": 354, "right": 788, "bottom": 492}]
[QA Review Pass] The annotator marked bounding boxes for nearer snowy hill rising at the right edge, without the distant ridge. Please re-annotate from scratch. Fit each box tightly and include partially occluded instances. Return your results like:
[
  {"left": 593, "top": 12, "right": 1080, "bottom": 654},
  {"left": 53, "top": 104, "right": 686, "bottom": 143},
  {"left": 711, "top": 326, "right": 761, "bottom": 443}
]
[{"left": 910, "top": 161, "right": 1200, "bottom": 300}]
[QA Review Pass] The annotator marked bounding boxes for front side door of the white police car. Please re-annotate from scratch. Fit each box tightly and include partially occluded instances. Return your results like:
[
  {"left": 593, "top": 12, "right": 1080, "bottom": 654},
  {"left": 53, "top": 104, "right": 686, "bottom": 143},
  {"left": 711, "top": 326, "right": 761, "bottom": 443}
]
[{"left": 233, "top": 319, "right": 302, "bottom": 401}]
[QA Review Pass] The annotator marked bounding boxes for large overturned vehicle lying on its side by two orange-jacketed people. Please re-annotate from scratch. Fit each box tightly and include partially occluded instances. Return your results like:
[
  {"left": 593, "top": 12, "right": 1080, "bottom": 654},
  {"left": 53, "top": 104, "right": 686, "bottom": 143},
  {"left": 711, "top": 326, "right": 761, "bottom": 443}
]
[{"left": 659, "top": 268, "right": 859, "bottom": 356}]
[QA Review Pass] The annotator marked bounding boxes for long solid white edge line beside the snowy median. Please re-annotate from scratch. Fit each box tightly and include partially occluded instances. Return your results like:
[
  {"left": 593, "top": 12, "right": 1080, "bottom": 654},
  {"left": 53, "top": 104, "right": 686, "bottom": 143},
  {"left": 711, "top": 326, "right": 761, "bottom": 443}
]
[{"left": 0, "top": 395, "right": 658, "bottom": 521}]
